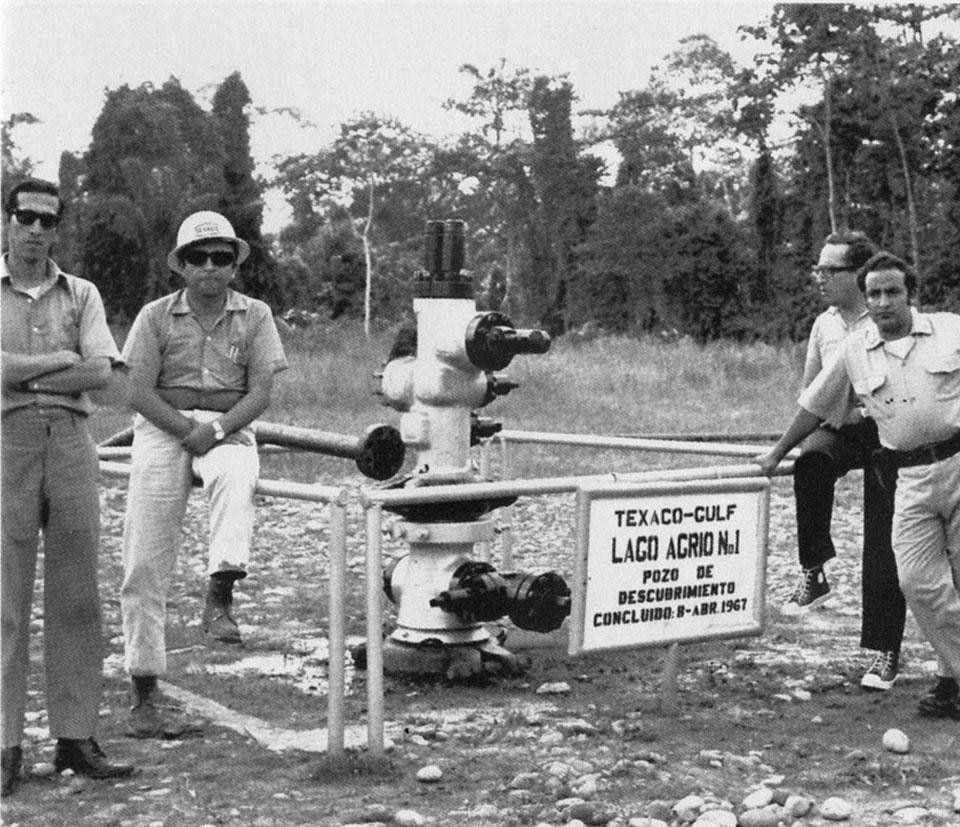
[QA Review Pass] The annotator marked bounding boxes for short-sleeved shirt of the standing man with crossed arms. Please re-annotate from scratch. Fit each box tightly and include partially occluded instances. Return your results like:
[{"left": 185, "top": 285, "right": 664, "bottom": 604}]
[{"left": 0, "top": 256, "right": 120, "bottom": 414}]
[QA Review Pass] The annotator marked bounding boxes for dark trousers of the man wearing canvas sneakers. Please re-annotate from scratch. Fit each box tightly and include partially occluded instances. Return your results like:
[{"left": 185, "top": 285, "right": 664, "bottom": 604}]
[{"left": 793, "top": 419, "right": 907, "bottom": 651}]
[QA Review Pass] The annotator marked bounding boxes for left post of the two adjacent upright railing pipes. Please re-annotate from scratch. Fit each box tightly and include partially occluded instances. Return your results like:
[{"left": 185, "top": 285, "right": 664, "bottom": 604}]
[{"left": 327, "top": 501, "right": 347, "bottom": 757}]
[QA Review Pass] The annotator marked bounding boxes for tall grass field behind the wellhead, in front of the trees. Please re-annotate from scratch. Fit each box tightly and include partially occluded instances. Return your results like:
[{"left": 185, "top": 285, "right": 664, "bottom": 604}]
[{"left": 94, "top": 322, "right": 802, "bottom": 480}]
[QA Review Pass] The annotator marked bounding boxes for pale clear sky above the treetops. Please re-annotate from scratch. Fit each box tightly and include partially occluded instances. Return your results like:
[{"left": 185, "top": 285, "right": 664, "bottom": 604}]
[{"left": 0, "top": 0, "right": 932, "bottom": 229}]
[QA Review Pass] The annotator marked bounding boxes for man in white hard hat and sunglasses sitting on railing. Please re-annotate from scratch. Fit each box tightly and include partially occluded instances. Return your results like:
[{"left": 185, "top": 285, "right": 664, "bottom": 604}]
[{"left": 121, "top": 211, "right": 287, "bottom": 738}]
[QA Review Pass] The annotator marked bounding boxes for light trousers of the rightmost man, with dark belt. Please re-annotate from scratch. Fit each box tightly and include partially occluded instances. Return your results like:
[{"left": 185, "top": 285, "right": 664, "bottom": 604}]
[{"left": 893, "top": 454, "right": 960, "bottom": 680}]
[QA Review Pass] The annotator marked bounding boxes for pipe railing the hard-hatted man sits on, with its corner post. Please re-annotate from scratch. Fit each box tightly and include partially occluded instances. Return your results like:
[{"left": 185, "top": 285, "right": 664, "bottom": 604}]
[{"left": 100, "top": 460, "right": 350, "bottom": 757}]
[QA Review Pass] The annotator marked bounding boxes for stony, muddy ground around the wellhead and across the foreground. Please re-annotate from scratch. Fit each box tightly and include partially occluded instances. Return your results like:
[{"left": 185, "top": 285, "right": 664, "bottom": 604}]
[{"left": 3, "top": 476, "right": 960, "bottom": 825}]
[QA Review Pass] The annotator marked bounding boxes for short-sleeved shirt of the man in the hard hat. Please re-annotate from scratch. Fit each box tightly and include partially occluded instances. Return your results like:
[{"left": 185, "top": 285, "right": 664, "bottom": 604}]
[{"left": 123, "top": 289, "right": 287, "bottom": 393}]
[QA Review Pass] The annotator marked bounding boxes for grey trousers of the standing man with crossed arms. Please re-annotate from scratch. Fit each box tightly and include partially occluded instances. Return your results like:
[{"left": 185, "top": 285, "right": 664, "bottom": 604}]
[{"left": 0, "top": 405, "right": 103, "bottom": 747}]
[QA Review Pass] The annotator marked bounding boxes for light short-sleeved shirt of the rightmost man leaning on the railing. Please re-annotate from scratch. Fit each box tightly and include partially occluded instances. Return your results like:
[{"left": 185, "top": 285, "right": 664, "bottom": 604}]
[{"left": 799, "top": 310, "right": 960, "bottom": 451}]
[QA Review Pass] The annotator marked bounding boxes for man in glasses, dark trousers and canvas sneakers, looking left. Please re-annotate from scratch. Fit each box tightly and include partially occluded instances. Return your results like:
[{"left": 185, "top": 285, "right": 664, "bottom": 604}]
[{"left": 783, "top": 231, "right": 906, "bottom": 691}]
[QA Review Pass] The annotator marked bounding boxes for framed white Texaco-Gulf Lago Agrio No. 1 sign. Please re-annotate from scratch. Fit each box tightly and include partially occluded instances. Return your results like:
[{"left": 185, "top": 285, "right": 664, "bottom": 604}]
[{"left": 569, "top": 477, "right": 770, "bottom": 655}]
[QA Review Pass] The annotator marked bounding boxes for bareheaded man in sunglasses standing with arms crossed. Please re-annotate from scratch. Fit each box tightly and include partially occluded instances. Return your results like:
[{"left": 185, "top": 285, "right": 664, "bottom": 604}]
[{"left": 0, "top": 179, "right": 133, "bottom": 796}]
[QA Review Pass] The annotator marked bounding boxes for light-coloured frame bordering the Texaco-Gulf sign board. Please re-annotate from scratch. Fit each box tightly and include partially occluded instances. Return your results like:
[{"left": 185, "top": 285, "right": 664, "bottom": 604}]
[{"left": 568, "top": 475, "right": 770, "bottom": 655}]
